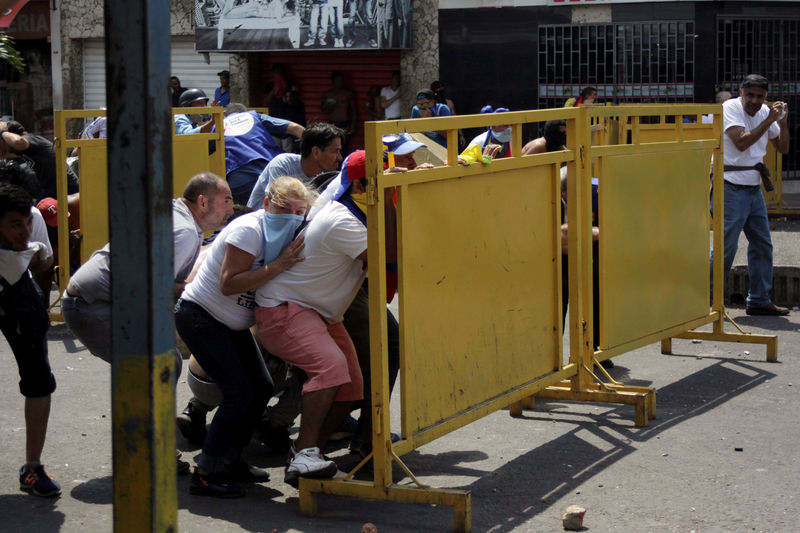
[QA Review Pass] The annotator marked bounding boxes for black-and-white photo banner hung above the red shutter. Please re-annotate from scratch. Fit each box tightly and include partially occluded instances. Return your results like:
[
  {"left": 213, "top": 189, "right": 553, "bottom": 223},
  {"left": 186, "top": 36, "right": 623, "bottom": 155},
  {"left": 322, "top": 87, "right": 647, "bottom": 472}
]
[{"left": 194, "top": 0, "right": 412, "bottom": 52}]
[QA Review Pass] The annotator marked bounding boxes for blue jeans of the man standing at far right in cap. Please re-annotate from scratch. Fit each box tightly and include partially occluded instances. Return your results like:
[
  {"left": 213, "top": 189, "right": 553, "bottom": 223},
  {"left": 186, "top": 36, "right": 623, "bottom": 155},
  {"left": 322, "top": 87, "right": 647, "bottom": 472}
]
[{"left": 711, "top": 183, "right": 772, "bottom": 307}]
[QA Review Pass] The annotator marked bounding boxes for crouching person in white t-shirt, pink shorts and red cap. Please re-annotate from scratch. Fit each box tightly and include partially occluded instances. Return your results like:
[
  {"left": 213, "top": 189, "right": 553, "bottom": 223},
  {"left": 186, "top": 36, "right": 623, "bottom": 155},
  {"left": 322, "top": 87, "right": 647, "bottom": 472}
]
[{"left": 255, "top": 150, "right": 367, "bottom": 485}]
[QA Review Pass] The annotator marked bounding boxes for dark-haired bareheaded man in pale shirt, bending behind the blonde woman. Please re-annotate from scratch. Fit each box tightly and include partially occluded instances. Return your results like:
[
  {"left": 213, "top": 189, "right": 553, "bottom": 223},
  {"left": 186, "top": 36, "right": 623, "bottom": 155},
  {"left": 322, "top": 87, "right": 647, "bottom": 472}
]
[{"left": 247, "top": 122, "right": 344, "bottom": 209}]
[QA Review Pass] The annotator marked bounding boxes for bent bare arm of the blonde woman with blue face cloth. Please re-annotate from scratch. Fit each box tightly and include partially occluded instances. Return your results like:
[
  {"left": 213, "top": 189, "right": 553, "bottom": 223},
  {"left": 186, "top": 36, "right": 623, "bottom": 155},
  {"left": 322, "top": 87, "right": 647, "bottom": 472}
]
[{"left": 219, "top": 235, "right": 305, "bottom": 296}]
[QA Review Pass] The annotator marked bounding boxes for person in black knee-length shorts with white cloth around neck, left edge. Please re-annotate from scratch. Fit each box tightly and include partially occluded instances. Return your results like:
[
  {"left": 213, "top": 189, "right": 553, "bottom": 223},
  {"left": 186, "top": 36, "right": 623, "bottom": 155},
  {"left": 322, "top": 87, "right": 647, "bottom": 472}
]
[{"left": 0, "top": 183, "right": 61, "bottom": 497}]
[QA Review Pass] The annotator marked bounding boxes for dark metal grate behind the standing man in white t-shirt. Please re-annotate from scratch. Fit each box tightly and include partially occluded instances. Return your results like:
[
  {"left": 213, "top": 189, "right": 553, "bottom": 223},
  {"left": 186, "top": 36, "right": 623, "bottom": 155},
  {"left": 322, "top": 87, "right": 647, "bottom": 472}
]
[{"left": 717, "top": 17, "right": 800, "bottom": 179}]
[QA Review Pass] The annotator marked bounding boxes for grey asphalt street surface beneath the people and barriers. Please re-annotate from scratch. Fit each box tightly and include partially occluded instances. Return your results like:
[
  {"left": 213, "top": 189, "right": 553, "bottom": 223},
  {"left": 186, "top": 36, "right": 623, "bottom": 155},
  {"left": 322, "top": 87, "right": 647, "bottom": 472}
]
[{"left": 0, "top": 221, "right": 800, "bottom": 533}]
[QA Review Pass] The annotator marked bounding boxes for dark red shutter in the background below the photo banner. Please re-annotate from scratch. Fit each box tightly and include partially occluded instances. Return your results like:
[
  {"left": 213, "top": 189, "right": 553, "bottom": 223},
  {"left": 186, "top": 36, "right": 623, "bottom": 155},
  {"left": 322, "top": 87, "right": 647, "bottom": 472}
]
[{"left": 259, "top": 50, "right": 410, "bottom": 151}]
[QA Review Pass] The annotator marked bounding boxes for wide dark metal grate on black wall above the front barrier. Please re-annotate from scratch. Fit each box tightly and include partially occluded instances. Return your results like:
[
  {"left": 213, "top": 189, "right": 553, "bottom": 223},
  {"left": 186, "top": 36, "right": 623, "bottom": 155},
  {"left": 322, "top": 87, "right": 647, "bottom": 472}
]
[{"left": 539, "top": 21, "right": 695, "bottom": 107}]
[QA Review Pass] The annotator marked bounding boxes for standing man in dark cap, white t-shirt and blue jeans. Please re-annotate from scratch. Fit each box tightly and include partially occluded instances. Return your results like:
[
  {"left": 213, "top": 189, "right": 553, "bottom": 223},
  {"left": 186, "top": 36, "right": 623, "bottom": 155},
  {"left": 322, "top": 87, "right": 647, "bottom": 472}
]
[{"left": 711, "top": 74, "right": 789, "bottom": 315}]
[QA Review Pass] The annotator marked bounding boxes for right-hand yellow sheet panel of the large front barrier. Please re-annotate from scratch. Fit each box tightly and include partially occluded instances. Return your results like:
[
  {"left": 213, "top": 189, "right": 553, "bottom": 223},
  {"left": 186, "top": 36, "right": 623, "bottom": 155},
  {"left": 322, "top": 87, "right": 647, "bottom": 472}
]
[{"left": 598, "top": 149, "right": 711, "bottom": 349}]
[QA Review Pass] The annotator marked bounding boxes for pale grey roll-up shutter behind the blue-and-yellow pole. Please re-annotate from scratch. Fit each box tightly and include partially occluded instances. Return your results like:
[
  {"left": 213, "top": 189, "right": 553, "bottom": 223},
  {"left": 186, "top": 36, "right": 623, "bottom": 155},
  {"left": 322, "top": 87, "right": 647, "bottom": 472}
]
[{"left": 83, "top": 37, "right": 229, "bottom": 109}]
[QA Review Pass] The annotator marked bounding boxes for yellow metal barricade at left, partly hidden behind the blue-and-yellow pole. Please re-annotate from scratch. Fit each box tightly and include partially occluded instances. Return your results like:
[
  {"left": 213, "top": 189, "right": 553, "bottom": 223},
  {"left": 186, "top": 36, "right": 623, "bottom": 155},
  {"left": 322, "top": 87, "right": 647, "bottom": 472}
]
[{"left": 50, "top": 107, "right": 225, "bottom": 320}]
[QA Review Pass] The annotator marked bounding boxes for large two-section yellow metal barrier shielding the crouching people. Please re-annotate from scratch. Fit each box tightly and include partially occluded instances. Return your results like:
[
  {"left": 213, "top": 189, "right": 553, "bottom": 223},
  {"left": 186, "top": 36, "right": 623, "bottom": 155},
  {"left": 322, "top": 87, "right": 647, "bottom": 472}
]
[{"left": 300, "top": 105, "right": 777, "bottom": 531}]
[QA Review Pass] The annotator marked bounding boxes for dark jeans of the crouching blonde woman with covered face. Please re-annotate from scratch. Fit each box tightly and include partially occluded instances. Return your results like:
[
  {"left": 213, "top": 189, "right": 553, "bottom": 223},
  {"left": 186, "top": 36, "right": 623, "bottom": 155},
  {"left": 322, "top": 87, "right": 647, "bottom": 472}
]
[{"left": 175, "top": 299, "right": 272, "bottom": 472}]
